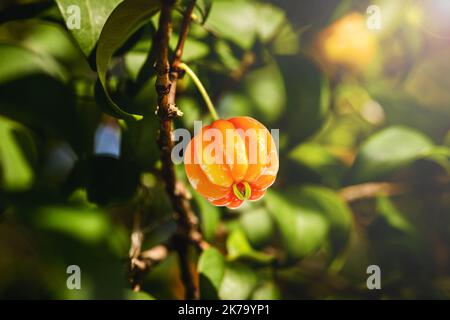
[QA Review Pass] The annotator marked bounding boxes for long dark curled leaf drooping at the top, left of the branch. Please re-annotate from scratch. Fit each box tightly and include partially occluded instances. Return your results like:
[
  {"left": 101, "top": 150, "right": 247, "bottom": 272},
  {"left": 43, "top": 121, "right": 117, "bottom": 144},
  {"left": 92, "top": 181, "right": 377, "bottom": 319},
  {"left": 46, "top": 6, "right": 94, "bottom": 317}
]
[{"left": 96, "top": 0, "right": 160, "bottom": 120}]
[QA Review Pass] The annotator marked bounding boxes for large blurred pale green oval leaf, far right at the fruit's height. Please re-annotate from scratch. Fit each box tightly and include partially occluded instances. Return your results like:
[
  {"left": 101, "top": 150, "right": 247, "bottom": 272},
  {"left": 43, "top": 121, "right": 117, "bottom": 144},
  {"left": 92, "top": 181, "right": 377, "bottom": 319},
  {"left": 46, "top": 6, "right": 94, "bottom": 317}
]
[{"left": 350, "top": 126, "right": 433, "bottom": 183}]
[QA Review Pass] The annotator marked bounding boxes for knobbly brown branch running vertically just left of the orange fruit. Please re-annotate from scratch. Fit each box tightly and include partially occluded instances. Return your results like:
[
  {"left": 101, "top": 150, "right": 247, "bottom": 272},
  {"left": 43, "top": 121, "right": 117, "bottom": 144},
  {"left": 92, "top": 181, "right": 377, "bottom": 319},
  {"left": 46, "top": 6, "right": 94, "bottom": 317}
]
[{"left": 156, "top": 0, "right": 203, "bottom": 299}]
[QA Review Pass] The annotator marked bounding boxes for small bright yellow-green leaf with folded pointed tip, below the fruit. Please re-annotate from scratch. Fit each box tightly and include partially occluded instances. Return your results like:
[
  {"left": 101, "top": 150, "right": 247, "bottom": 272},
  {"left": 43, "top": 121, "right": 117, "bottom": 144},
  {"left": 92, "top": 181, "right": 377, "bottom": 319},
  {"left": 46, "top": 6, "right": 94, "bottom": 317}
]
[{"left": 227, "top": 228, "right": 273, "bottom": 265}]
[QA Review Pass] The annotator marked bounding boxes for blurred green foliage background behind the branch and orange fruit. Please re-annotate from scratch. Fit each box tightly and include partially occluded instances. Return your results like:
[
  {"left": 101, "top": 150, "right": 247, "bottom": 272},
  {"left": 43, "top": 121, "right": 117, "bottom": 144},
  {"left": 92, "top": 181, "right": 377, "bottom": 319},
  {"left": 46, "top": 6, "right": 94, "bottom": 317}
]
[{"left": 0, "top": 0, "right": 450, "bottom": 299}]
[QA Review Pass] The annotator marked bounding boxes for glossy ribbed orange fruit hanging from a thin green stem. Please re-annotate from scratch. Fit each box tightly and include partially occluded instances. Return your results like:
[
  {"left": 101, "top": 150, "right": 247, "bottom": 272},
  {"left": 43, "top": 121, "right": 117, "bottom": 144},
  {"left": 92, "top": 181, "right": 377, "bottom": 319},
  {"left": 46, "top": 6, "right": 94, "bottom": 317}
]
[{"left": 184, "top": 117, "right": 279, "bottom": 209}]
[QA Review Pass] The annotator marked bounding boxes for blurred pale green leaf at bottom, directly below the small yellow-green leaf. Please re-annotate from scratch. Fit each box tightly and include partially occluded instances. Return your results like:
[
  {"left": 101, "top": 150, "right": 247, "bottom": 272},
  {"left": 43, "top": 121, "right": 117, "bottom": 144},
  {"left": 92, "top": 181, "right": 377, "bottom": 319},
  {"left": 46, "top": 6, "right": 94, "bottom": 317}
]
[{"left": 219, "top": 262, "right": 258, "bottom": 300}]
